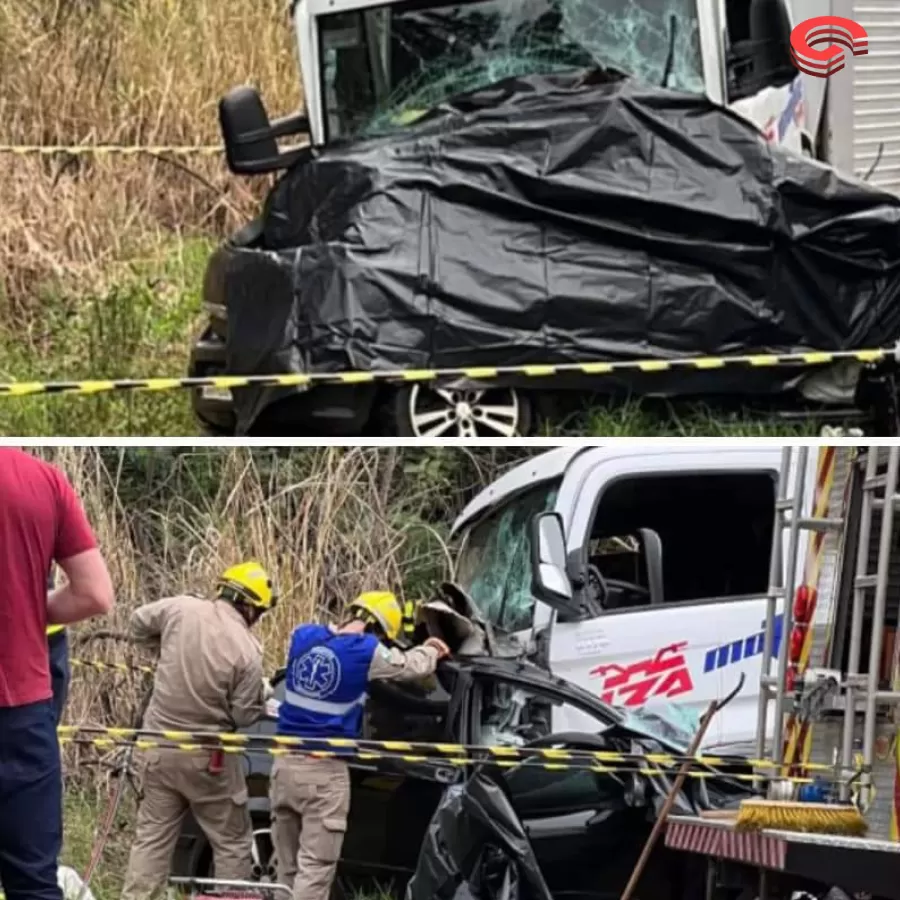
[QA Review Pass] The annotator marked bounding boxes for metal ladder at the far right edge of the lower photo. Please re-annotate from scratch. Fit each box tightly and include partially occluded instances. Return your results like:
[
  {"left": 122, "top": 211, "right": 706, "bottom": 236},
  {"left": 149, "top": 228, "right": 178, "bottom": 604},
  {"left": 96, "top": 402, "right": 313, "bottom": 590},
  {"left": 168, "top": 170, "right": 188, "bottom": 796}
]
[{"left": 840, "top": 446, "right": 900, "bottom": 804}]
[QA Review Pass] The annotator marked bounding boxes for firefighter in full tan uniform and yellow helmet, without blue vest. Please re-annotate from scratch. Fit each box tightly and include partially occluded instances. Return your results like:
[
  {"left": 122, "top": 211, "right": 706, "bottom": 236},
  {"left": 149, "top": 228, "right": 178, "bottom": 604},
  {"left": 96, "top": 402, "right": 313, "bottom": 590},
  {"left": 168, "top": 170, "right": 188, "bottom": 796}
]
[{"left": 122, "top": 562, "right": 275, "bottom": 900}]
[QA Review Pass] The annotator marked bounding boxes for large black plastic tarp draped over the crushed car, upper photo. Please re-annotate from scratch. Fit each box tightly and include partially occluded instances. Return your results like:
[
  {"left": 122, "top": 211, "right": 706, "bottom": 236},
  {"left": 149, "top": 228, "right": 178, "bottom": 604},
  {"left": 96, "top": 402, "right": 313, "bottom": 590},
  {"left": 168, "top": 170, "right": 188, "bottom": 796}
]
[{"left": 225, "top": 72, "right": 900, "bottom": 431}]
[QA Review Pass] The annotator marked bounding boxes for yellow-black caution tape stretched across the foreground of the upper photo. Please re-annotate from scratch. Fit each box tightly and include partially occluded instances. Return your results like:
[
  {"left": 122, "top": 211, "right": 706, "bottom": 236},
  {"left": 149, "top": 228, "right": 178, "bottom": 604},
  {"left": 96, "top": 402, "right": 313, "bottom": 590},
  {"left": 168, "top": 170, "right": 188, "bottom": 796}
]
[{"left": 0, "top": 349, "right": 895, "bottom": 397}]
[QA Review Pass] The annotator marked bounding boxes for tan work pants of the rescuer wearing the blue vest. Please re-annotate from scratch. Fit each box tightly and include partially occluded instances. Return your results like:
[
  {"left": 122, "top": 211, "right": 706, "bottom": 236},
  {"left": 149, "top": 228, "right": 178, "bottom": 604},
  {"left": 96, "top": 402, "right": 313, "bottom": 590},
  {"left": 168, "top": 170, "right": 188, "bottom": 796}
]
[{"left": 269, "top": 756, "right": 350, "bottom": 900}]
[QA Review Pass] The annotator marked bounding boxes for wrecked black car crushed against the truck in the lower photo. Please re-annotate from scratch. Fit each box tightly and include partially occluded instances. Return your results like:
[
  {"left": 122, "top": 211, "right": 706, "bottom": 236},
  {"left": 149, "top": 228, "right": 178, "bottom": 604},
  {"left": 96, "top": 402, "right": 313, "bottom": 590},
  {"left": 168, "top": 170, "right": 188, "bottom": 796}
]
[{"left": 173, "top": 585, "right": 749, "bottom": 900}]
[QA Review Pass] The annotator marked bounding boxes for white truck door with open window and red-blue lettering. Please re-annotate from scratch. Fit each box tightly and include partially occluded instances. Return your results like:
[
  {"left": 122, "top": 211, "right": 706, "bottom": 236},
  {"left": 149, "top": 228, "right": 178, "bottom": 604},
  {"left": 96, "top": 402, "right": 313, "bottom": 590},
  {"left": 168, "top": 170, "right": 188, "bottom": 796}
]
[{"left": 536, "top": 451, "right": 780, "bottom": 746}]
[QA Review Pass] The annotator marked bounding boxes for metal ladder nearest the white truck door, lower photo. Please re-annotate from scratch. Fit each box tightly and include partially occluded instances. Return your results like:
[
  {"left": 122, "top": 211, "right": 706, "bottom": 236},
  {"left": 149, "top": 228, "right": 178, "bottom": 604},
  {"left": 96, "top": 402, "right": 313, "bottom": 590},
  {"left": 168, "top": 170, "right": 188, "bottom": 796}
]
[{"left": 756, "top": 446, "right": 845, "bottom": 782}]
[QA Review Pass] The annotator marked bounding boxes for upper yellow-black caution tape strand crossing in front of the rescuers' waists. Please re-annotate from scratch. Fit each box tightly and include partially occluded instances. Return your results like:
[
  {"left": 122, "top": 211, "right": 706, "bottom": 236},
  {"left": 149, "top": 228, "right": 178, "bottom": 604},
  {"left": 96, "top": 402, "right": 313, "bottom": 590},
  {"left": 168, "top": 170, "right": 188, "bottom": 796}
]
[{"left": 58, "top": 725, "right": 834, "bottom": 778}]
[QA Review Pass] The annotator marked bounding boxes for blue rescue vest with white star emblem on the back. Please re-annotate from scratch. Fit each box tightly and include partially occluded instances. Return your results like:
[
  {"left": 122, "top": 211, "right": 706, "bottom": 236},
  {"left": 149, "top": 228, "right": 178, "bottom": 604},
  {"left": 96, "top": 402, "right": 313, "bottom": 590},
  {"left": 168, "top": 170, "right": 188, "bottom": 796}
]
[{"left": 278, "top": 625, "right": 379, "bottom": 738}]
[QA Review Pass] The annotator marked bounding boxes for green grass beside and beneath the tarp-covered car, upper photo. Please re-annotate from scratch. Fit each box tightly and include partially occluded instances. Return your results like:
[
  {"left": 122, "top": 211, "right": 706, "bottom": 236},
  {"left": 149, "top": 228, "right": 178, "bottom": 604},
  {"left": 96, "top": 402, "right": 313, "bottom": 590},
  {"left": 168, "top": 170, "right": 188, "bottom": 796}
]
[{"left": 0, "top": 241, "right": 836, "bottom": 437}]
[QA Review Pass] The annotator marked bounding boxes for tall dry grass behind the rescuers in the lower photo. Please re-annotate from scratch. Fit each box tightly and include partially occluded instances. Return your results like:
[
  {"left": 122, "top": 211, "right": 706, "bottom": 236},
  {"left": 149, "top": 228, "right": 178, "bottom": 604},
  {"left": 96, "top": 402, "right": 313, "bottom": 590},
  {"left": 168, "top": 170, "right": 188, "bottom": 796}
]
[{"left": 42, "top": 447, "right": 539, "bottom": 900}]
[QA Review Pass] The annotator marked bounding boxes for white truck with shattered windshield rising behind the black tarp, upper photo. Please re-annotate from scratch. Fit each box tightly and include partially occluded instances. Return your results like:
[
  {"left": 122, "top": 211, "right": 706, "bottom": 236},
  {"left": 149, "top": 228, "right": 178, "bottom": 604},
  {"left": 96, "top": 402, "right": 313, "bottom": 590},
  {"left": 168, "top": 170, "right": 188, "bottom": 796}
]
[{"left": 219, "top": 0, "right": 900, "bottom": 191}]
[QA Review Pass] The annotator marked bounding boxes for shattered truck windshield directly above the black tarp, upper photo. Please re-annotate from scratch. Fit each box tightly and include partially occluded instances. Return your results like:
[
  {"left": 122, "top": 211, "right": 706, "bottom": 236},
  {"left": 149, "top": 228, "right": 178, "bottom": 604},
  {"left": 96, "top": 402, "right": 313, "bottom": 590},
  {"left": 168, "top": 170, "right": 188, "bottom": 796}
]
[{"left": 319, "top": 0, "right": 704, "bottom": 140}]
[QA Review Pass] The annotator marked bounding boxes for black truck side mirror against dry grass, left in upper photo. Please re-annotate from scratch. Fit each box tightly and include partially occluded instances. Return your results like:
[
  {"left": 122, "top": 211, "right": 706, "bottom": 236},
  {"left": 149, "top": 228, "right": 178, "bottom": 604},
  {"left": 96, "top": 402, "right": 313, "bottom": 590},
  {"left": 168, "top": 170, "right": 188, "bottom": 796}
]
[{"left": 219, "top": 86, "right": 311, "bottom": 175}]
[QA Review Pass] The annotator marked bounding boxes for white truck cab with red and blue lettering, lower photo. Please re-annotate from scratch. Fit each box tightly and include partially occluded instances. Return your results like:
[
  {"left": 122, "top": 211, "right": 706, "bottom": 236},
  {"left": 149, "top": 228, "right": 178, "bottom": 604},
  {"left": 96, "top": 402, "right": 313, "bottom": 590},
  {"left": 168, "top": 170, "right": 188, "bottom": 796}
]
[{"left": 452, "top": 441, "right": 828, "bottom": 752}]
